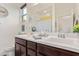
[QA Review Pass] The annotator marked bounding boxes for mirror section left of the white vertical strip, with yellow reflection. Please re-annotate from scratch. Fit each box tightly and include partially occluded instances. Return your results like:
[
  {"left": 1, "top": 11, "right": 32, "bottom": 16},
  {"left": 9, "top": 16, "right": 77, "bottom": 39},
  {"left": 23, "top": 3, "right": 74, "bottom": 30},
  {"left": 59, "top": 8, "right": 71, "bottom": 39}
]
[{"left": 27, "top": 3, "right": 52, "bottom": 32}]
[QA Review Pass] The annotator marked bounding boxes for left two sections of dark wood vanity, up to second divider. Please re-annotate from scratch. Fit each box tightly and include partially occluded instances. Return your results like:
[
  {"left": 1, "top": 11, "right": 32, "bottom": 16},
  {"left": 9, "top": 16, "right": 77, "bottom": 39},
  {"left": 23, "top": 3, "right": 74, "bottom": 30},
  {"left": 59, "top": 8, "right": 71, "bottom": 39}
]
[{"left": 15, "top": 38, "right": 37, "bottom": 56}]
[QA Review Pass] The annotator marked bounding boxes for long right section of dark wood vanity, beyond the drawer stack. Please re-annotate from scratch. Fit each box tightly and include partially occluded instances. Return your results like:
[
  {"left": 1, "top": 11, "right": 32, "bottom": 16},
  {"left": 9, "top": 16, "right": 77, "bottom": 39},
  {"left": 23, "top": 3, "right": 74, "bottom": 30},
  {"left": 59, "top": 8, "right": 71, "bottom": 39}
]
[{"left": 37, "top": 43, "right": 79, "bottom": 56}]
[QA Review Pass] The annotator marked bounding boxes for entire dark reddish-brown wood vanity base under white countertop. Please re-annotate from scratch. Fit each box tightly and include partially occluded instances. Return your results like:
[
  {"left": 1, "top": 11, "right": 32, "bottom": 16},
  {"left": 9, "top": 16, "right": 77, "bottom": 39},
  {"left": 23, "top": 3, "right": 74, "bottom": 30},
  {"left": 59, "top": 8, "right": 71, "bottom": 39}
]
[{"left": 15, "top": 38, "right": 79, "bottom": 56}]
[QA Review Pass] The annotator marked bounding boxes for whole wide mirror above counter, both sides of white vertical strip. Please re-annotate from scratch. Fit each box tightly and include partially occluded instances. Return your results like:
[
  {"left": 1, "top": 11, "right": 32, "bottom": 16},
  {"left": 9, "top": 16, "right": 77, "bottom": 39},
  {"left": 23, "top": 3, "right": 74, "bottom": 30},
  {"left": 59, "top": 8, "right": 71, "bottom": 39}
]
[{"left": 21, "top": 3, "right": 79, "bottom": 33}]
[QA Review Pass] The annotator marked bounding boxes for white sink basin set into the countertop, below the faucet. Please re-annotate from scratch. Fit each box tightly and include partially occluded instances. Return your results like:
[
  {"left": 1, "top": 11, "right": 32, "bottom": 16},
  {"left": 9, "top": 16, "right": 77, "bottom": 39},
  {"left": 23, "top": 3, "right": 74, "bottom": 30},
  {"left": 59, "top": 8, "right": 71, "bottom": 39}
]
[{"left": 43, "top": 37, "right": 76, "bottom": 45}]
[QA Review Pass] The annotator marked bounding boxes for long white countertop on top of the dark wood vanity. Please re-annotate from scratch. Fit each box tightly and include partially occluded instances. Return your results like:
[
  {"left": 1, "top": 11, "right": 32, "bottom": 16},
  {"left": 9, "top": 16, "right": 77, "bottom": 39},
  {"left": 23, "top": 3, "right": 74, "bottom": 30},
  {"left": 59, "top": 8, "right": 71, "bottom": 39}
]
[{"left": 16, "top": 35, "right": 79, "bottom": 53}]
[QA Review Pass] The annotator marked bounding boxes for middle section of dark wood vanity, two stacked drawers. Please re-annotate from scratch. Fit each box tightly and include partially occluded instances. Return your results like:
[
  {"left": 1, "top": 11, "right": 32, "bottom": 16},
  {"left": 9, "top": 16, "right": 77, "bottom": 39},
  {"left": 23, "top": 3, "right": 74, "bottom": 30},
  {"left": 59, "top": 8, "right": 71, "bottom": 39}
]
[{"left": 27, "top": 41, "right": 37, "bottom": 56}]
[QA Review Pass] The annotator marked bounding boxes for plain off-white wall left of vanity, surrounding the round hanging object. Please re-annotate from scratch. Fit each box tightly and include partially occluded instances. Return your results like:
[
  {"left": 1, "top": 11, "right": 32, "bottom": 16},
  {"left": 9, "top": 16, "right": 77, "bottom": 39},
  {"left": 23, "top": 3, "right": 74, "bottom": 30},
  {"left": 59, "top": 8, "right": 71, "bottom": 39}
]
[{"left": 0, "top": 3, "right": 19, "bottom": 53}]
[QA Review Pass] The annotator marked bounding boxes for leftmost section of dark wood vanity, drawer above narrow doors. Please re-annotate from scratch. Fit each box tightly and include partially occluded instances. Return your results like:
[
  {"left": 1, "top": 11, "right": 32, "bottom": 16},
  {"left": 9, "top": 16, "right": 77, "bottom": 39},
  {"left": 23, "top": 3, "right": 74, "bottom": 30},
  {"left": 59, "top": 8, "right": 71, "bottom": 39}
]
[{"left": 15, "top": 38, "right": 27, "bottom": 56}]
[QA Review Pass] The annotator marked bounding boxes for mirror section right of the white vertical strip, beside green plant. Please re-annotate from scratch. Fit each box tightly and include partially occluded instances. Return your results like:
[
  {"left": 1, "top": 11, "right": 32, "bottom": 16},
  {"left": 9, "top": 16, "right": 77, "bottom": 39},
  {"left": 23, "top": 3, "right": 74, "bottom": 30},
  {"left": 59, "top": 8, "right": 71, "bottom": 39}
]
[{"left": 55, "top": 3, "right": 76, "bottom": 33}]
